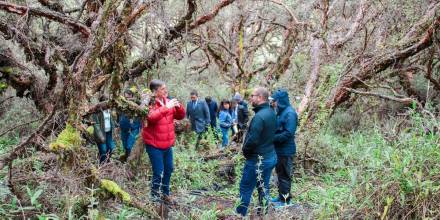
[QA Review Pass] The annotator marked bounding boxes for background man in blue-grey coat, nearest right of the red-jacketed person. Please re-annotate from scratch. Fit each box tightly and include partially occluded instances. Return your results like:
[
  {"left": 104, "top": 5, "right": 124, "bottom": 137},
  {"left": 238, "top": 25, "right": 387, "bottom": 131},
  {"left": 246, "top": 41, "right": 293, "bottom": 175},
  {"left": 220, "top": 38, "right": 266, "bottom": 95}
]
[{"left": 186, "top": 90, "right": 211, "bottom": 149}]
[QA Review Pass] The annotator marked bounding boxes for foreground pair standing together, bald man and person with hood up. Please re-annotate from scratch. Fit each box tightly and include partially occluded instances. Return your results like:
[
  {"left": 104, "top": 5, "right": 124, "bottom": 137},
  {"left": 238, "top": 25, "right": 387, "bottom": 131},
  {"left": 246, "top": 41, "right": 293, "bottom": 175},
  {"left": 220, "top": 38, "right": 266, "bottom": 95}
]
[{"left": 237, "top": 87, "right": 298, "bottom": 216}]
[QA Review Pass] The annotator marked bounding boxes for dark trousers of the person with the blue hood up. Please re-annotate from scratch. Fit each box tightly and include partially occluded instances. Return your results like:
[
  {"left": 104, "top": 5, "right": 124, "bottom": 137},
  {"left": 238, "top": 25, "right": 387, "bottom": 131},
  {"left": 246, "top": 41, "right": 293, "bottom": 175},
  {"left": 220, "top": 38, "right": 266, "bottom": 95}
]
[{"left": 275, "top": 156, "right": 294, "bottom": 202}]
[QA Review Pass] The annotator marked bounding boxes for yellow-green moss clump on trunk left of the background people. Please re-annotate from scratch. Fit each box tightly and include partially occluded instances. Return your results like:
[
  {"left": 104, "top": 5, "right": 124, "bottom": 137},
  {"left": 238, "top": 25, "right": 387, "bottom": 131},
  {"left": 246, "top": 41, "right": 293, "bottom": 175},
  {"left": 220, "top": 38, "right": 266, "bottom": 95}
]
[{"left": 49, "top": 124, "right": 81, "bottom": 151}]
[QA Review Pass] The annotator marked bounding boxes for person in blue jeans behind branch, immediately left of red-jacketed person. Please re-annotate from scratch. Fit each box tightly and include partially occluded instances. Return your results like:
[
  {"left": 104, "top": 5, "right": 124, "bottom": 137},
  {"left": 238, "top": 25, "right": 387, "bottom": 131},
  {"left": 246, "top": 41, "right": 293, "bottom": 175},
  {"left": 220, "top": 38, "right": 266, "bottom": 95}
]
[{"left": 117, "top": 89, "right": 141, "bottom": 161}]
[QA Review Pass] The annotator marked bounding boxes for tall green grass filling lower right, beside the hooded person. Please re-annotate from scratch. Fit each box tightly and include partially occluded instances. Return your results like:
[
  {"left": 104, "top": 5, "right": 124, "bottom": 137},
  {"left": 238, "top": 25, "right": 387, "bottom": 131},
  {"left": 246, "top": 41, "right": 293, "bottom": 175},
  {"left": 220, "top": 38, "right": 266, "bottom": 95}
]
[{"left": 294, "top": 112, "right": 440, "bottom": 219}]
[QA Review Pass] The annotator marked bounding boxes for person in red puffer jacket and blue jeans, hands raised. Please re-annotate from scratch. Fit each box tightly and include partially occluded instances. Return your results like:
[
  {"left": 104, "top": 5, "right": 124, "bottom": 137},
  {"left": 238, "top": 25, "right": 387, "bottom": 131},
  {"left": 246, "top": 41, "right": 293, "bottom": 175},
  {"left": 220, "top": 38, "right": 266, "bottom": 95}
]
[{"left": 142, "top": 80, "right": 185, "bottom": 202}]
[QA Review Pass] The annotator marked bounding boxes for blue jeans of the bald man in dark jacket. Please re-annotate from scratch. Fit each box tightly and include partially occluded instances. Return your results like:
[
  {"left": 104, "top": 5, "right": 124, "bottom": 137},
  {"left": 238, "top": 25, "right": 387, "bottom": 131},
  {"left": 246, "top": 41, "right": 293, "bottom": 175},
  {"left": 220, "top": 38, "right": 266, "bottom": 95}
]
[{"left": 236, "top": 154, "right": 277, "bottom": 216}]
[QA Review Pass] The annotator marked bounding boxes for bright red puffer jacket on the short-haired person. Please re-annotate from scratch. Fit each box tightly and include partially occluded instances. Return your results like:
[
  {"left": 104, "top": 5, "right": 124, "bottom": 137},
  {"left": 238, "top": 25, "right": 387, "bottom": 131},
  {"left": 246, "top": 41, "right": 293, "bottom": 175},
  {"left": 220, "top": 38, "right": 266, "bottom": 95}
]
[{"left": 142, "top": 99, "right": 185, "bottom": 150}]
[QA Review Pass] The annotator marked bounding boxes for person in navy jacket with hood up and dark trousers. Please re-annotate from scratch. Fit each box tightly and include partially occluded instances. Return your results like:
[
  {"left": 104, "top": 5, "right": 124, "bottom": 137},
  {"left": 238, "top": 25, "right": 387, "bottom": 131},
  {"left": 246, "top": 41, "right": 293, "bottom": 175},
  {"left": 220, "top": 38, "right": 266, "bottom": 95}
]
[{"left": 272, "top": 89, "right": 298, "bottom": 205}]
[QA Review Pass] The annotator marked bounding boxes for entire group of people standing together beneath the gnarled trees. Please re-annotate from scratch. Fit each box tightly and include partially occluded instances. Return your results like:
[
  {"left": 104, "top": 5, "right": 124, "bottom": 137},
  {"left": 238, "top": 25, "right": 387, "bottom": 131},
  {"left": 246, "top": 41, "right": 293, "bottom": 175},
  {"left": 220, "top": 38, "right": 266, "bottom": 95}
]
[{"left": 89, "top": 80, "right": 298, "bottom": 216}]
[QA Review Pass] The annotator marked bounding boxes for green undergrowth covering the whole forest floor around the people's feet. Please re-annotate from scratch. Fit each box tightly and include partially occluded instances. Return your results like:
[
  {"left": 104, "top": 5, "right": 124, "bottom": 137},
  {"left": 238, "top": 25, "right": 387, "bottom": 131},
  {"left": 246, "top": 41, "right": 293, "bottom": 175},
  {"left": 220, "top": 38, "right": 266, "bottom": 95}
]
[{"left": 0, "top": 103, "right": 440, "bottom": 219}]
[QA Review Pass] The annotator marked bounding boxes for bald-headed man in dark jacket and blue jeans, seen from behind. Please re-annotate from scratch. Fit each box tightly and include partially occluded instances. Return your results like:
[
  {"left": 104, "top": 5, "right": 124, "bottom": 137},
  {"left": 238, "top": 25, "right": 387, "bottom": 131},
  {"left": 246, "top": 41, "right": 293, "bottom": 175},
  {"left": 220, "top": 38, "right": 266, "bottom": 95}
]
[{"left": 236, "top": 87, "right": 277, "bottom": 216}]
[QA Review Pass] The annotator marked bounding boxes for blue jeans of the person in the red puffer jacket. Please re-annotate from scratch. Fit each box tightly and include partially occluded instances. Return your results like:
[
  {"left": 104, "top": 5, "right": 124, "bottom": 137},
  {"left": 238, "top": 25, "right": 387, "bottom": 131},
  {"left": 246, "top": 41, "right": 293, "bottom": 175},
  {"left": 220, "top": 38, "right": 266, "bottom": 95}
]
[{"left": 145, "top": 145, "right": 174, "bottom": 198}]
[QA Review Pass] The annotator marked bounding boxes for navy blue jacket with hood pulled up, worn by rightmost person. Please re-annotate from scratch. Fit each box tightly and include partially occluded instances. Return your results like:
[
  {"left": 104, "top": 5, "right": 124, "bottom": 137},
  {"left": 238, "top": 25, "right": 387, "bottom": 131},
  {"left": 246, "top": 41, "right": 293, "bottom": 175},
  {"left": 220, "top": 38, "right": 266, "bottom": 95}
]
[{"left": 272, "top": 89, "right": 298, "bottom": 156}]
